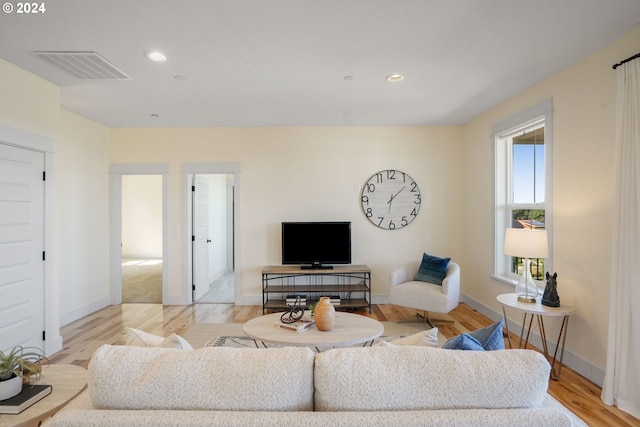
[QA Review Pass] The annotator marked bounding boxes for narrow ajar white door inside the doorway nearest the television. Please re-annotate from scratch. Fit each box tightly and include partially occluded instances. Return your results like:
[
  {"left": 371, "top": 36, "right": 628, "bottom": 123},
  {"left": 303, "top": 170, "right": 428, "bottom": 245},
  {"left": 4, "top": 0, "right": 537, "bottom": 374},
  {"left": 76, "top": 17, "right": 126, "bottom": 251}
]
[{"left": 192, "top": 175, "right": 211, "bottom": 301}]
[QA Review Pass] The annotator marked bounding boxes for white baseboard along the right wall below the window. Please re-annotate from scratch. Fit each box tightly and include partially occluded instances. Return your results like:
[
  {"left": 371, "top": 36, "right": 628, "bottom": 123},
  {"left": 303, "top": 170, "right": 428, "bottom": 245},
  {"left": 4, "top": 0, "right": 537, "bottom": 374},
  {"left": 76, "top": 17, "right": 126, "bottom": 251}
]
[{"left": 462, "top": 295, "right": 604, "bottom": 387}]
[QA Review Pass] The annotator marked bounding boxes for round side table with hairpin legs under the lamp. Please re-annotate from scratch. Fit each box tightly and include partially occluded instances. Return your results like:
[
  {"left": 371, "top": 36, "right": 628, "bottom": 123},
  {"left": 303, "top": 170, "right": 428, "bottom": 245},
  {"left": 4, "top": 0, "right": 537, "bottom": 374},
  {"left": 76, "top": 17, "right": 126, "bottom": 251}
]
[{"left": 496, "top": 294, "right": 575, "bottom": 380}]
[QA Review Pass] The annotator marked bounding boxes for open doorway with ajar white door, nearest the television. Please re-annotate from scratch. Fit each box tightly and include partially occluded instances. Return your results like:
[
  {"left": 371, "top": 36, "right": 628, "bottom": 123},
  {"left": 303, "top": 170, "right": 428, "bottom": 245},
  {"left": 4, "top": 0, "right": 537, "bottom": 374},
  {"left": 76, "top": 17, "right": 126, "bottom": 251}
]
[{"left": 191, "top": 173, "right": 235, "bottom": 304}]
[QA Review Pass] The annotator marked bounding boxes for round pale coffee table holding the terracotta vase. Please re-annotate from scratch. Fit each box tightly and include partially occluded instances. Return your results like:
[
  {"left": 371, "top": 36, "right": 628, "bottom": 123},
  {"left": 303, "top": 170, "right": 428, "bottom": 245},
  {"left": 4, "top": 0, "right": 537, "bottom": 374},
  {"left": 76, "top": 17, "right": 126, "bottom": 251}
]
[{"left": 242, "top": 311, "right": 384, "bottom": 349}]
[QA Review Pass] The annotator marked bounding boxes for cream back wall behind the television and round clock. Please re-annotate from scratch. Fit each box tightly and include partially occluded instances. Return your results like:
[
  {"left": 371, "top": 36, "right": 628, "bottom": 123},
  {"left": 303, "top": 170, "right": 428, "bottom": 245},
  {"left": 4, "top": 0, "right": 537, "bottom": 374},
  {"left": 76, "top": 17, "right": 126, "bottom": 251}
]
[{"left": 110, "top": 127, "right": 463, "bottom": 304}]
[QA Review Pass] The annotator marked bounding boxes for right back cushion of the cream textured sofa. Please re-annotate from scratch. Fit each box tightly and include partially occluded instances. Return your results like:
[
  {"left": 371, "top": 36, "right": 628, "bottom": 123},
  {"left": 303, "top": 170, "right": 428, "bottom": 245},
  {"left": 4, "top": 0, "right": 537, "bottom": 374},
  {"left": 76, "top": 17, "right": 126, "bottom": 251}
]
[{"left": 315, "top": 346, "right": 551, "bottom": 411}]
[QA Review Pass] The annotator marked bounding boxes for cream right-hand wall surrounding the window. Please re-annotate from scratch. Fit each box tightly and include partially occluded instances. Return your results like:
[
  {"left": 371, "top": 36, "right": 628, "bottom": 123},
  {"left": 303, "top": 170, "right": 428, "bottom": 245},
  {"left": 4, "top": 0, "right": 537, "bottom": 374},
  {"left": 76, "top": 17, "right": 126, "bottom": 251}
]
[{"left": 462, "top": 25, "right": 640, "bottom": 379}]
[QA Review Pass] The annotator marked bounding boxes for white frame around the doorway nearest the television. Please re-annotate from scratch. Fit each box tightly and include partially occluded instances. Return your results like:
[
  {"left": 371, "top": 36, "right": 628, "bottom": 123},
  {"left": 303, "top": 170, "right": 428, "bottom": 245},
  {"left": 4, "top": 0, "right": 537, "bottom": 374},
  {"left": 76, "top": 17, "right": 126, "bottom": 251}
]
[{"left": 182, "top": 162, "right": 242, "bottom": 304}]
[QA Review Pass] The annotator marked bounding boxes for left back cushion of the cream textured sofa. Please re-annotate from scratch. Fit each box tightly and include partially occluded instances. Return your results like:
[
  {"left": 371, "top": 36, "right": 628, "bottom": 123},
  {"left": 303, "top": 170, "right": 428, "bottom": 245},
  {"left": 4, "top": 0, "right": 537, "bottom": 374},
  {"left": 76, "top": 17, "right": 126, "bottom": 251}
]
[{"left": 88, "top": 345, "right": 314, "bottom": 411}]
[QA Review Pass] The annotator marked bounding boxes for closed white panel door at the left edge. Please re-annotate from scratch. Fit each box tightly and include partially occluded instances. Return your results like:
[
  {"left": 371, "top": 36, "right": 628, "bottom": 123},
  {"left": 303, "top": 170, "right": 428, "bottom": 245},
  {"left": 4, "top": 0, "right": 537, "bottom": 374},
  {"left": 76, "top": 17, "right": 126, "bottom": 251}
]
[{"left": 0, "top": 144, "right": 45, "bottom": 351}]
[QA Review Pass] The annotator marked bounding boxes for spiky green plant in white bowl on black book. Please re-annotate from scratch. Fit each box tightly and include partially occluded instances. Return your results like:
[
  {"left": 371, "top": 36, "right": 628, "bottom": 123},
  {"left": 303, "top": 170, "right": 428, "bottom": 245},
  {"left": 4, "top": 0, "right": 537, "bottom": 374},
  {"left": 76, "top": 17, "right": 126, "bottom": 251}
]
[{"left": 0, "top": 346, "right": 47, "bottom": 400}]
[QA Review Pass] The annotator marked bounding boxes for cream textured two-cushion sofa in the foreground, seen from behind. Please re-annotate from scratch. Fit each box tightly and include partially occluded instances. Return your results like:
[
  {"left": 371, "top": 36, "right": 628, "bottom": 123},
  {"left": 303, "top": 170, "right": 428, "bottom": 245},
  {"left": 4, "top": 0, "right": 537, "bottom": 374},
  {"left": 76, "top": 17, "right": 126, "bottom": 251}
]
[{"left": 47, "top": 345, "right": 585, "bottom": 427}]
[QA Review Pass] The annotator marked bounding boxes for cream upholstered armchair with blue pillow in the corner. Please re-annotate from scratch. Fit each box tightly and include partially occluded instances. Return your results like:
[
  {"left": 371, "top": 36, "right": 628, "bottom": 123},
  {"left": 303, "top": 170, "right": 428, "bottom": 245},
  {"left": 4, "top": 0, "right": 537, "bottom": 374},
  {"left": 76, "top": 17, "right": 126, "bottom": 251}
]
[{"left": 389, "top": 260, "right": 460, "bottom": 327}]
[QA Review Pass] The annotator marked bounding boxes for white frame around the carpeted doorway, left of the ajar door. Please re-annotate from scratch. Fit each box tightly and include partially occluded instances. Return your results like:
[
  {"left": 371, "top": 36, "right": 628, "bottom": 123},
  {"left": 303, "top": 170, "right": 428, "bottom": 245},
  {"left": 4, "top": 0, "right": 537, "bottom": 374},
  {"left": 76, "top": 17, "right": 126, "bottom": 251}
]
[{"left": 109, "top": 163, "right": 169, "bottom": 305}]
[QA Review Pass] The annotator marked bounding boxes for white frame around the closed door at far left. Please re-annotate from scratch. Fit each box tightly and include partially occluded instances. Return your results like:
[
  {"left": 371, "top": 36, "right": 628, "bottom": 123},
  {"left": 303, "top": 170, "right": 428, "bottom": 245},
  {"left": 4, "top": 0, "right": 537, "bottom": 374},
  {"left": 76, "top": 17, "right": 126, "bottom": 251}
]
[{"left": 0, "top": 124, "right": 62, "bottom": 355}]
